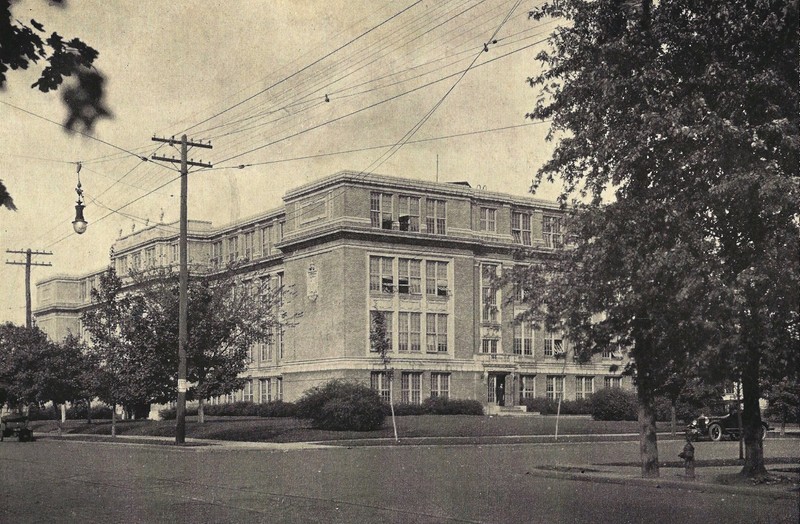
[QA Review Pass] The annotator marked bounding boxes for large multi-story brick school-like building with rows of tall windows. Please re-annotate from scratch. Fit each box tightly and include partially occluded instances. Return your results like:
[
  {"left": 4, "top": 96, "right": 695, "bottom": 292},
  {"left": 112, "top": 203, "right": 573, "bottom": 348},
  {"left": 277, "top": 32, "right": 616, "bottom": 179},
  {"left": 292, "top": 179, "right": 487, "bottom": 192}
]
[{"left": 35, "top": 172, "right": 630, "bottom": 414}]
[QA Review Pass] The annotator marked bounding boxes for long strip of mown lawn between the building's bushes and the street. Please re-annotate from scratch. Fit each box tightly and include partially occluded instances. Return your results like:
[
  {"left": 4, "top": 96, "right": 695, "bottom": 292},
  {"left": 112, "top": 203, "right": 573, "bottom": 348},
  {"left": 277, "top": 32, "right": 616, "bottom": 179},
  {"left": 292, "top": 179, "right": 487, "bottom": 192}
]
[{"left": 31, "top": 415, "right": 648, "bottom": 444}]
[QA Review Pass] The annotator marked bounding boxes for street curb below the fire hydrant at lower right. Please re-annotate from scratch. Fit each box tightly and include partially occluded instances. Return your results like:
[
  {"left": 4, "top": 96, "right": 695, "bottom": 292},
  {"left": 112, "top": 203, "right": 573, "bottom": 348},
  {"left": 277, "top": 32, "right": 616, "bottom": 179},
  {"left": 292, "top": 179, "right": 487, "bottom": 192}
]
[{"left": 526, "top": 466, "right": 797, "bottom": 499}]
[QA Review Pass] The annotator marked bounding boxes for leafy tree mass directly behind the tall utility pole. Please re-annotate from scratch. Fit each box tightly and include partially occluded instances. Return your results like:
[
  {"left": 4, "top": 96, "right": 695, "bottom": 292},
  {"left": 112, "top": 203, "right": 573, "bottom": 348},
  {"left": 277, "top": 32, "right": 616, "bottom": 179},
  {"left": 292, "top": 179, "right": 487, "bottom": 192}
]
[{"left": 84, "top": 268, "right": 291, "bottom": 421}]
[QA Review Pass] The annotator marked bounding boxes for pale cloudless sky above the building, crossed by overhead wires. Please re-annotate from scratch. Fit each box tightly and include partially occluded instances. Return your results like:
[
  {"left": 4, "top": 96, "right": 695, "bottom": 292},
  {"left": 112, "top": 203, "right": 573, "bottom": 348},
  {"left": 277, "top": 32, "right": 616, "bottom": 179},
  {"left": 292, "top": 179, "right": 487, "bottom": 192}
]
[{"left": 0, "top": 0, "right": 559, "bottom": 324}]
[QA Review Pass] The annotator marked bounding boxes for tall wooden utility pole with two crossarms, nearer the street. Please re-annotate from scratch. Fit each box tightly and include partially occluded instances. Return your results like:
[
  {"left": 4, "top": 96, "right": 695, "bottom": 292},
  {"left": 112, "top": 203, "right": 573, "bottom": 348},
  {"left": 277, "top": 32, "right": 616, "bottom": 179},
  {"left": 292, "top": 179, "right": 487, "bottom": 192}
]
[{"left": 152, "top": 135, "right": 212, "bottom": 444}]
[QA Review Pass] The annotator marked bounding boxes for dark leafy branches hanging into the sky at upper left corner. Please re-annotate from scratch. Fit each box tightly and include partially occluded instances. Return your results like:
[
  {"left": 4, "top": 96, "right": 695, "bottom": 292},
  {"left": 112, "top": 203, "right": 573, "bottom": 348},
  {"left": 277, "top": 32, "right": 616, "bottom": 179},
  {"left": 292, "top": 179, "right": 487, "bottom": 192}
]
[{"left": 0, "top": 0, "right": 111, "bottom": 211}]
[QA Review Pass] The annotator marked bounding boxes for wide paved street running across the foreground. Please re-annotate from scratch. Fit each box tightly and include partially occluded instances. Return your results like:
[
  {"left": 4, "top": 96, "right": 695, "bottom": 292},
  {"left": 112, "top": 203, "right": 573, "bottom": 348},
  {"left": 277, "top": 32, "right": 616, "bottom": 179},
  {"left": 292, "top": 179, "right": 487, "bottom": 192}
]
[{"left": 0, "top": 439, "right": 798, "bottom": 523}]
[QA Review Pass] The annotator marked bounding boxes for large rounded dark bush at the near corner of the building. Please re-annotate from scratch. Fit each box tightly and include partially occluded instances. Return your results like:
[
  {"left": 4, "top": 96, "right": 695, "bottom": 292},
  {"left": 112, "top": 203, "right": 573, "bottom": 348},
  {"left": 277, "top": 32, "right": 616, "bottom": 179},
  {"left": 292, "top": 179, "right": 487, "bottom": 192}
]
[{"left": 295, "top": 380, "right": 385, "bottom": 431}]
